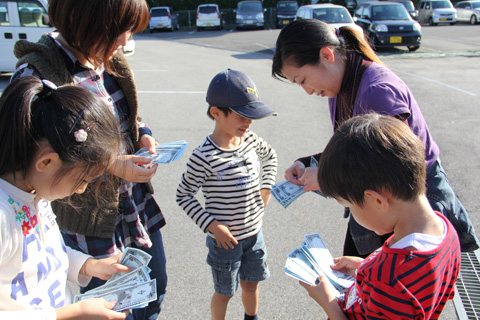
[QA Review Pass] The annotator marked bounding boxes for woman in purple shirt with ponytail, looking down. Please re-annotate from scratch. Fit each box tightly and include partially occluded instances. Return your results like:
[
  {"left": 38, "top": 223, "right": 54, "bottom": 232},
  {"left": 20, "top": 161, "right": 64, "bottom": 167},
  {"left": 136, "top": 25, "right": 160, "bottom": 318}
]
[{"left": 272, "top": 19, "right": 479, "bottom": 257}]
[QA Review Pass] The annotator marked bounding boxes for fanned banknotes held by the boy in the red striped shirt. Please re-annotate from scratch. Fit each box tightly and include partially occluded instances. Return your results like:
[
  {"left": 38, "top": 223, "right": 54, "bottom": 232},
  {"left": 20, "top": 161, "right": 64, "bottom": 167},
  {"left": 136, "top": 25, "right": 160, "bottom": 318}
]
[{"left": 284, "top": 233, "right": 355, "bottom": 298}]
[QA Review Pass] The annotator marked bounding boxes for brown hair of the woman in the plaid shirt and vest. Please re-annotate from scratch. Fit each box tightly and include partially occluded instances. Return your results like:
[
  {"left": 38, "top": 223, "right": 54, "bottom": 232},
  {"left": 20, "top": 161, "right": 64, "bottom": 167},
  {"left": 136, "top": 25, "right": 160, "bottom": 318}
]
[{"left": 48, "top": 0, "right": 150, "bottom": 71}]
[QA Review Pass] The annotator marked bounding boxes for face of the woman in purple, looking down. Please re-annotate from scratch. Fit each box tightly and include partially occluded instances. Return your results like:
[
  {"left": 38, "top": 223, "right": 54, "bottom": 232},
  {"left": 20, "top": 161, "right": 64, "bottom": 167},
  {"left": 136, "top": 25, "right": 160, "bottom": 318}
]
[{"left": 282, "top": 48, "right": 344, "bottom": 98}]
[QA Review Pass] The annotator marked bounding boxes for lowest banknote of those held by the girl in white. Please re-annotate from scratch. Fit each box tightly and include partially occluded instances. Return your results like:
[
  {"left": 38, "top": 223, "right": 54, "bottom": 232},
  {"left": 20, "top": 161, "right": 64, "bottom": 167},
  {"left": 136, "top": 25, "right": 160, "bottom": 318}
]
[{"left": 74, "top": 280, "right": 157, "bottom": 311}]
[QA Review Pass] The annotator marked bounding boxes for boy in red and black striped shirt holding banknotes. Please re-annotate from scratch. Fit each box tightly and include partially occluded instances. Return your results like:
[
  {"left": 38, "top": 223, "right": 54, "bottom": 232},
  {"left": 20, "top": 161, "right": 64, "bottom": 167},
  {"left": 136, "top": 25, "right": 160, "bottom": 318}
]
[{"left": 301, "top": 114, "right": 460, "bottom": 319}]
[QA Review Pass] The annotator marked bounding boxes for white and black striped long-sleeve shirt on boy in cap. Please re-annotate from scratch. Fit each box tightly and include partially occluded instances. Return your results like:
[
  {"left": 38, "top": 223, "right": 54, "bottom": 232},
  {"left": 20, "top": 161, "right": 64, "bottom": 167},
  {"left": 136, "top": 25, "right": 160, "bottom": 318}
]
[{"left": 177, "top": 131, "right": 277, "bottom": 240}]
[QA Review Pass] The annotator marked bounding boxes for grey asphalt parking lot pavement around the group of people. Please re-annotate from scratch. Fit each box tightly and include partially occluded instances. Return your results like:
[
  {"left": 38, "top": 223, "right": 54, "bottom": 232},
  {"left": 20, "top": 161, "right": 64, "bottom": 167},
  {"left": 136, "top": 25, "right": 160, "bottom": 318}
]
[{"left": 0, "top": 25, "right": 480, "bottom": 320}]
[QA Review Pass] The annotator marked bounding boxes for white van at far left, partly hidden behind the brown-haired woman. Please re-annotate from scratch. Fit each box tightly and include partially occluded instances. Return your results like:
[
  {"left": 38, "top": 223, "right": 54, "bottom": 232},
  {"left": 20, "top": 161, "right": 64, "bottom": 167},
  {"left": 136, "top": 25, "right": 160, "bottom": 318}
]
[{"left": 0, "top": 0, "right": 54, "bottom": 72}]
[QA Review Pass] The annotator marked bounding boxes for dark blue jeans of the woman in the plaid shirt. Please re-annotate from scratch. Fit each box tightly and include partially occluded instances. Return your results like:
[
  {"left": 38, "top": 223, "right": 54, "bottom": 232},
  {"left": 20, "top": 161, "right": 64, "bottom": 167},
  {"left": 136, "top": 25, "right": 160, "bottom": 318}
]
[{"left": 64, "top": 230, "right": 167, "bottom": 320}]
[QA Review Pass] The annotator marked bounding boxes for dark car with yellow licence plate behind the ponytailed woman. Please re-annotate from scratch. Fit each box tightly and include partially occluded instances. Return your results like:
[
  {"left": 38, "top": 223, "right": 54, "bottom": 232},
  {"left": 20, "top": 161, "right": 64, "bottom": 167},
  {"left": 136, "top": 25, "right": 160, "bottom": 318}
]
[{"left": 353, "top": 1, "right": 422, "bottom": 51}]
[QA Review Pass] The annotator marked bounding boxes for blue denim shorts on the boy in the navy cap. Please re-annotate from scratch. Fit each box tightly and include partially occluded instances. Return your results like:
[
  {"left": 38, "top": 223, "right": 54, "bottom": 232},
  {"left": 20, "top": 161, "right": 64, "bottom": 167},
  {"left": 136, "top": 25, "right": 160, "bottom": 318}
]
[{"left": 206, "top": 230, "right": 270, "bottom": 296}]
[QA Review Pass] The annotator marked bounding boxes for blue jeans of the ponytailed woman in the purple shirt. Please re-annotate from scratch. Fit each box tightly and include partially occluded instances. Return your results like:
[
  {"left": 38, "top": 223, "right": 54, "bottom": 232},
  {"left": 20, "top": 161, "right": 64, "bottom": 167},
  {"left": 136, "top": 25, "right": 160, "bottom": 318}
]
[{"left": 343, "top": 159, "right": 479, "bottom": 256}]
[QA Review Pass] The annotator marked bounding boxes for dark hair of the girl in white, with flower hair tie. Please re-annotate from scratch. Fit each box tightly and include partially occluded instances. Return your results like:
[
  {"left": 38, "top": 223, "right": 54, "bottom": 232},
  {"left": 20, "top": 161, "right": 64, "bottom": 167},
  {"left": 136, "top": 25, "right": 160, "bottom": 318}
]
[{"left": 0, "top": 76, "right": 120, "bottom": 191}]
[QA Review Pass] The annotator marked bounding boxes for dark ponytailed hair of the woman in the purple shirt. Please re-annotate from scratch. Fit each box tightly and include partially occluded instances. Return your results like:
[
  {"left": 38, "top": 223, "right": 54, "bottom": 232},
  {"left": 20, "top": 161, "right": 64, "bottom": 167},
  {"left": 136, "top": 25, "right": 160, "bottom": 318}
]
[{"left": 272, "top": 19, "right": 383, "bottom": 80}]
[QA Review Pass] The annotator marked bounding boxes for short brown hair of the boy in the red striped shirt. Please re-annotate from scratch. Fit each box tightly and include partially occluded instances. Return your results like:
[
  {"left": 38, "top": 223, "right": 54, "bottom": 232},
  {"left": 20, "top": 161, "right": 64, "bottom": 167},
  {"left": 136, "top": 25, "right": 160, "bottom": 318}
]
[{"left": 318, "top": 114, "right": 426, "bottom": 206}]
